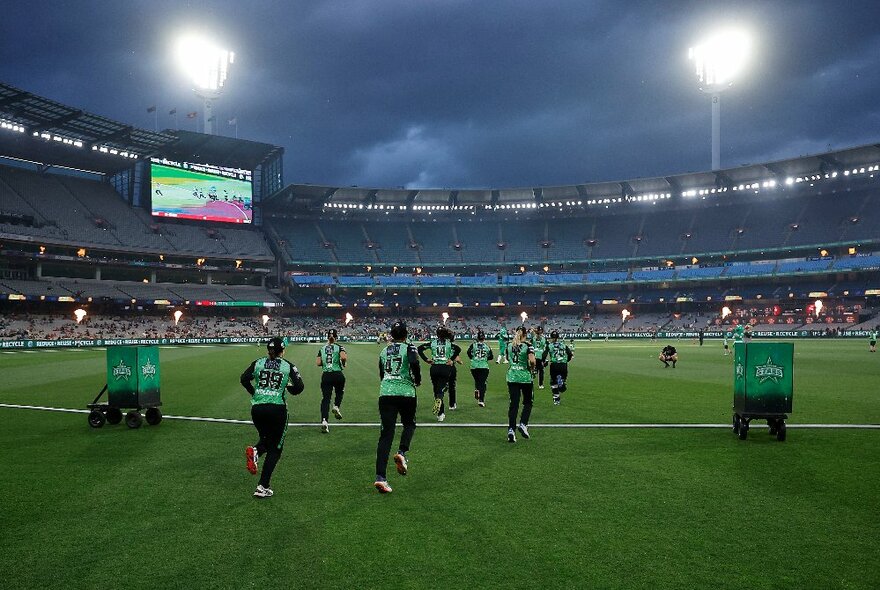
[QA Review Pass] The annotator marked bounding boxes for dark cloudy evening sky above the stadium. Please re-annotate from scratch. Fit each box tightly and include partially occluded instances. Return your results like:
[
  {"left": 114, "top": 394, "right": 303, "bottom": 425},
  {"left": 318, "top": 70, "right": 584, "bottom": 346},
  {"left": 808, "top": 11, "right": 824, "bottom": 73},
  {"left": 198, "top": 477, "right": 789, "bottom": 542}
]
[{"left": 0, "top": 0, "right": 880, "bottom": 188}]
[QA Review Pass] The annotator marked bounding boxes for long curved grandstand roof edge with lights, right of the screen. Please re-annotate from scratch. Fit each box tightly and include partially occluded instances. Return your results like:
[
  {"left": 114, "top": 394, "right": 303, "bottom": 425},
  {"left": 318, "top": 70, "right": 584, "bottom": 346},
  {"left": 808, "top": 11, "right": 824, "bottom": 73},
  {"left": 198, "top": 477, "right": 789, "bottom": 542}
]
[{"left": 269, "top": 144, "right": 880, "bottom": 209}]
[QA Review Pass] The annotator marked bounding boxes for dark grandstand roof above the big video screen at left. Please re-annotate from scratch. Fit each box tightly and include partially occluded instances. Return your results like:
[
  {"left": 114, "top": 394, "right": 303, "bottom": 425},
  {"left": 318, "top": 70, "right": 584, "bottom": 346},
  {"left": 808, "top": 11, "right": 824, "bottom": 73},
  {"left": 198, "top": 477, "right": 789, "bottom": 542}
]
[{"left": 0, "top": 82, "right": 284, "bottom": 174}]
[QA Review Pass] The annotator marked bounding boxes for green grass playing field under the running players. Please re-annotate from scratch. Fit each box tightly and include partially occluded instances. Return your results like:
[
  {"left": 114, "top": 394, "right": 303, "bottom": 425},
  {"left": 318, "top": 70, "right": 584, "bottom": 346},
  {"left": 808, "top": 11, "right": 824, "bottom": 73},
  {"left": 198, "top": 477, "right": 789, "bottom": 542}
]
[{"left": 0, "top": 340, "right": 880, "bottom": 589}]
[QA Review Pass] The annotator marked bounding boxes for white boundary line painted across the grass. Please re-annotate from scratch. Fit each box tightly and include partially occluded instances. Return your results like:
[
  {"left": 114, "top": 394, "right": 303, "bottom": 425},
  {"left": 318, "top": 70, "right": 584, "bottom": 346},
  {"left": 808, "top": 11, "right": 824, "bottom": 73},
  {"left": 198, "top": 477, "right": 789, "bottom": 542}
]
[{"left": 0, "top": 403, "right": 880, "bottom": 430}]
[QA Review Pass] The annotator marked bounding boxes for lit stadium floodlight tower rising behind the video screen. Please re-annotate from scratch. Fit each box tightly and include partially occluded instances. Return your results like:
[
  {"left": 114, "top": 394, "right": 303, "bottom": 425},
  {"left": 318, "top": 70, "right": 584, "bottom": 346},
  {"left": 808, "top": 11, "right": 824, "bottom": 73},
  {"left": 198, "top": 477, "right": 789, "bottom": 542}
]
[{"left": 175, "top": 35, "right": 235, "bottom": 135}]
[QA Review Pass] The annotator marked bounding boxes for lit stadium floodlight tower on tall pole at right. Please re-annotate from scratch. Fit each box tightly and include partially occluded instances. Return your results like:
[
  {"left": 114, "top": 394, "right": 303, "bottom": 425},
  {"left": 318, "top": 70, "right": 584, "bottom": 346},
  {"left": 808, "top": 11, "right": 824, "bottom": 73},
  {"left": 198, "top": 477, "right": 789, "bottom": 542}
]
[{"left": 688, "top": 30, "right": 751, "bottom": 170}]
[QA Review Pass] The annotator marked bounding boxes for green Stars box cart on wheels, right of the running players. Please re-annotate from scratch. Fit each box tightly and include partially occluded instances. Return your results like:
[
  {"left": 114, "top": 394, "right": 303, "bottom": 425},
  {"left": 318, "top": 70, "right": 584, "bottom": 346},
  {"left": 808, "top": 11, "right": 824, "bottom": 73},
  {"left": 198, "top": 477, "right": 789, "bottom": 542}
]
[{"left": 733, "top": 342, "right": 794, "bottom": 441}]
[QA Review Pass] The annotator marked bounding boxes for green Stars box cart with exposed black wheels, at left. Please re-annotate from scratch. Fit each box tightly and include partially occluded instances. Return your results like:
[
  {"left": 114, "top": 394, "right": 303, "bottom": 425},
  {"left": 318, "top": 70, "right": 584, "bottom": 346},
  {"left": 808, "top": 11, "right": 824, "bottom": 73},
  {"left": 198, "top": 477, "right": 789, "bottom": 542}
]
[{"left": 88, "top": 346, "right": 162, "bottom": 428}]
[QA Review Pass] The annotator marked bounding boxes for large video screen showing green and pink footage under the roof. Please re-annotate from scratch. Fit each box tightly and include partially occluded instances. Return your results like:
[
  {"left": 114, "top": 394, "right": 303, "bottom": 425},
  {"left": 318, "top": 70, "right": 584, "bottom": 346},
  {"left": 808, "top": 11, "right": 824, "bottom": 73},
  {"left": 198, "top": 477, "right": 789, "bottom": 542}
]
[{"left": 150, "top": 158, "right": 253, "bottom": 223}]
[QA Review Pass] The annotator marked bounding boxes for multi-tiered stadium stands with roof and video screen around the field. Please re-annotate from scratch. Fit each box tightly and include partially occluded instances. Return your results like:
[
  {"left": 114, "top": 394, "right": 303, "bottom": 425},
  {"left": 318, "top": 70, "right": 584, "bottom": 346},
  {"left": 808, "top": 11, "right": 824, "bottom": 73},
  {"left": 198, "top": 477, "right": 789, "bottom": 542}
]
[{"left": 0, "top": 84, "right": 880, "bottom": 338}]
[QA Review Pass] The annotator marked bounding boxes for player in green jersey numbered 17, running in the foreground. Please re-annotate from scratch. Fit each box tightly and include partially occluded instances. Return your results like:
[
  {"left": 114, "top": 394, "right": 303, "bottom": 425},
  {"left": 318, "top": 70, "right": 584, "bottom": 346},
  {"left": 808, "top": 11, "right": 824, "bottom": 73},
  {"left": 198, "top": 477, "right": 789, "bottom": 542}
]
[{"left": 374, "top": 320, "right": 422, "bottom": 494}]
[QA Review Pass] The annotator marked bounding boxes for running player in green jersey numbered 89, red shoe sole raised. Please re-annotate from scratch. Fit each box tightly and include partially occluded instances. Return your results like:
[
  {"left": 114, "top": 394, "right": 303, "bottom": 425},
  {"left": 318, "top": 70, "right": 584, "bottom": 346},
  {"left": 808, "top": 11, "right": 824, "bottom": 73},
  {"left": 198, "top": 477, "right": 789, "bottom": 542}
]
[{"left": 241, "top": 338, "right": 305, "bottom": 498}]
